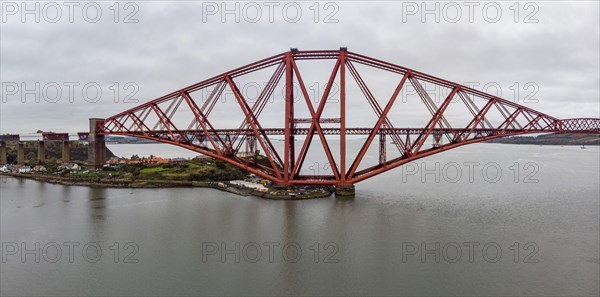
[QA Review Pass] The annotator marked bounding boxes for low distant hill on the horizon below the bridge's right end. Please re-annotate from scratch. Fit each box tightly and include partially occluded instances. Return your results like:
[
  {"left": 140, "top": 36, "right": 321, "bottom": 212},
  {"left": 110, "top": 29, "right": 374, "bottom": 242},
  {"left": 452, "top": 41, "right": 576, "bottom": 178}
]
[{"left": 487, "top": 133, "right": 600, "bottom": 145}]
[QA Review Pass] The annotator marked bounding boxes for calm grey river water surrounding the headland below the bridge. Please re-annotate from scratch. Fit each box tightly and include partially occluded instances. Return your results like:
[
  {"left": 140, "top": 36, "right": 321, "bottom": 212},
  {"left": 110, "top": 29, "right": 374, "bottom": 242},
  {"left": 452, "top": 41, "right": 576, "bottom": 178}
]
[{"left": 0, "top": 144, "right": 600, "bottom": 296}]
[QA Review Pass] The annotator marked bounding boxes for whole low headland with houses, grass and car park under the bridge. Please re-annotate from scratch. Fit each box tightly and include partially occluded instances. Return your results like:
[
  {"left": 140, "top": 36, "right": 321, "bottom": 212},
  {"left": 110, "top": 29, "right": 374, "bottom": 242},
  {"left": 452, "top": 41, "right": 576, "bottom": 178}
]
[{"left": 0, "top": 155, "right": 333, "bottom": 199}]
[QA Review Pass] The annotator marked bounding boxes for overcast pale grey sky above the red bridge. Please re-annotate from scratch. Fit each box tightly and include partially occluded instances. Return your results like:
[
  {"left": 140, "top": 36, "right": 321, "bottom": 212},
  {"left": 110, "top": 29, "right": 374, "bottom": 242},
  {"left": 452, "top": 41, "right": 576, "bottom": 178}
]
[{"left": 0, "top": 1, "right": 600, "bottom": 133}]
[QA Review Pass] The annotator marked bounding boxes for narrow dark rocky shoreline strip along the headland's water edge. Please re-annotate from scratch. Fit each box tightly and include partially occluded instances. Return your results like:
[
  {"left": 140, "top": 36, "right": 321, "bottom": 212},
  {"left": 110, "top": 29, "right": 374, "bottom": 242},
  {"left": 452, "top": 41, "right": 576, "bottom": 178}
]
[{"left": 0, "top": 173, "right": 333, "bottom": 200}]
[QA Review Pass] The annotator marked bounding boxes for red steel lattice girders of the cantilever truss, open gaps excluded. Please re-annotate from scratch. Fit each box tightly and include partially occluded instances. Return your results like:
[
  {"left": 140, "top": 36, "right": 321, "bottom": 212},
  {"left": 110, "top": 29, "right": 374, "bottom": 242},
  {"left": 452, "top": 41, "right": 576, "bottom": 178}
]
[{"left": 97, "top": 49, "right": 600, "bottom": 185}]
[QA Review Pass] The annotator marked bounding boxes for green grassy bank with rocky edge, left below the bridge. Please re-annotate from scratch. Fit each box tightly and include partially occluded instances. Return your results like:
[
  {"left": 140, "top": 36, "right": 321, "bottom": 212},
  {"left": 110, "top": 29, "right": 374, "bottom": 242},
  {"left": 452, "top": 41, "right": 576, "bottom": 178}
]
[{"left": 4, "top": 159, "right": 333, "bottom": 200}]
